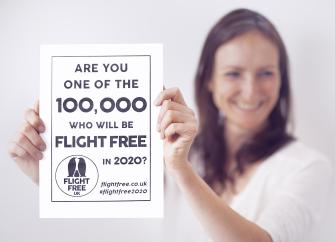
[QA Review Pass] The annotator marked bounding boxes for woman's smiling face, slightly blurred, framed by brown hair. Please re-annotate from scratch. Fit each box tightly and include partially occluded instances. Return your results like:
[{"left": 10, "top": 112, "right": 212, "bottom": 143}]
[{"left": 208, "top": 31, "right": 281, "bottom": 131}]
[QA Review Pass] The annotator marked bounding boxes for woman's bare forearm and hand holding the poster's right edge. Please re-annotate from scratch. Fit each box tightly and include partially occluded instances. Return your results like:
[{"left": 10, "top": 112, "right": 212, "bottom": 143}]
[{"left": 155, "top": 88, "right": 272, "bottom": 242}]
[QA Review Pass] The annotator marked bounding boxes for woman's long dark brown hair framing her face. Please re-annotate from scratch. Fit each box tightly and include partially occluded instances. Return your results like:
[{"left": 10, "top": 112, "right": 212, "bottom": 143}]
[{"left": 191, "top": 9, "right": 294, "bottom": 193}]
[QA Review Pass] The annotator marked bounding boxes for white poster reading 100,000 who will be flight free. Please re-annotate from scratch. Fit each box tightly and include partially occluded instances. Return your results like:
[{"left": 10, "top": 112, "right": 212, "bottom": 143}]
[{"left": 40, "top": 44, "right": 164, "bottom": 218}]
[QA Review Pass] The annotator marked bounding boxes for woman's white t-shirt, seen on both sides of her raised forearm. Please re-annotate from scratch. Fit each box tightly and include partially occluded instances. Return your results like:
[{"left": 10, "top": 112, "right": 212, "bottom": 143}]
[{"left": 164, "top": 141, "right": 334, "bottom": 242}]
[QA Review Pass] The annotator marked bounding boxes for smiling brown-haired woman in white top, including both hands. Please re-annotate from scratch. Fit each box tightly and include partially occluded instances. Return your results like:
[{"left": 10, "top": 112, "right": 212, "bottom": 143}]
[{"left": 10, "top": 9, "right": 332, "bottom": 242}]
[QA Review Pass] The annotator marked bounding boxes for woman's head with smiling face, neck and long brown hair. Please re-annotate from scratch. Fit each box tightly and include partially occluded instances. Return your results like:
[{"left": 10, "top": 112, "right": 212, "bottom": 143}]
[{"left": 193, "top": 9, "right": 294, "bottom": 197}]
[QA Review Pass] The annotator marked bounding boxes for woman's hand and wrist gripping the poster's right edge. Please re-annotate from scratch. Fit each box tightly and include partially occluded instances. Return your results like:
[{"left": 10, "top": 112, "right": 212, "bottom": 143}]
[{"left": 155, "top": 88, "right": 198, "bottom": 172}]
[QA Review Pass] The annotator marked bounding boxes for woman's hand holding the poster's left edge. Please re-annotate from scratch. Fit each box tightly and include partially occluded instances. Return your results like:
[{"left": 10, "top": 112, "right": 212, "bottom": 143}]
[{"left": 9, "top": 101, "right": 46, "bottom": 184}]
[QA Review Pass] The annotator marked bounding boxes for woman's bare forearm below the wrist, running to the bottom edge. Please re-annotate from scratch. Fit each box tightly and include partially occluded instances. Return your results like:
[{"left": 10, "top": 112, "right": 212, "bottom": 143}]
[{"left": 169, "top": 161, "right": 272, "bottom": 242}]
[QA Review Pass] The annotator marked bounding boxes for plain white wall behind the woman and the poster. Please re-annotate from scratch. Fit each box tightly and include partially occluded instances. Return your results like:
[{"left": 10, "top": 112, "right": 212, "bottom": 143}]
[{"left": 0, "top": 0, "right": 335, "bottom": 242}]
